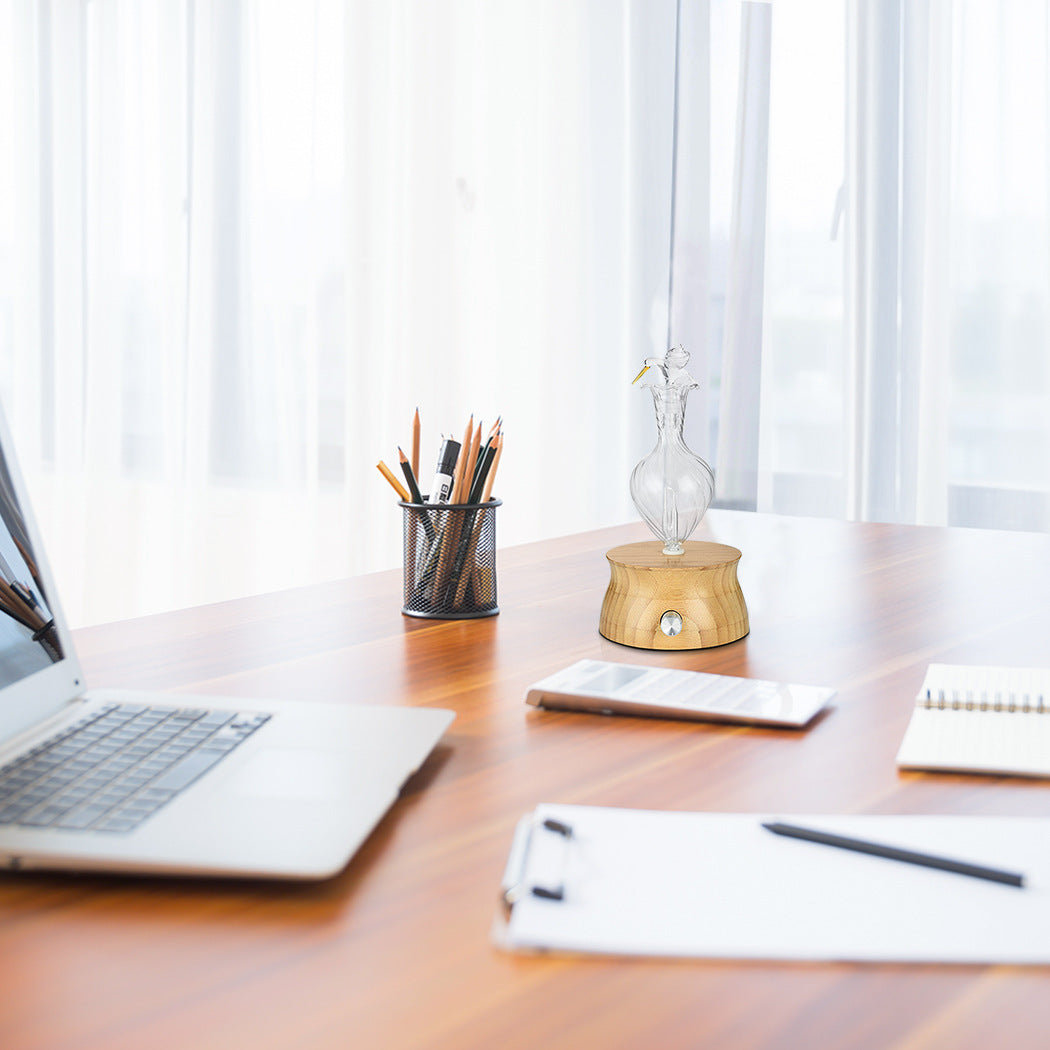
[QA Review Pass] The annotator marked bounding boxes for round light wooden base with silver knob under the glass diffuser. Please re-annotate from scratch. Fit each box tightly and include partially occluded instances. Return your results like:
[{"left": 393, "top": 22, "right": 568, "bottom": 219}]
[{"left": 599, "top": 540, "right": 750, "bottom": 649}]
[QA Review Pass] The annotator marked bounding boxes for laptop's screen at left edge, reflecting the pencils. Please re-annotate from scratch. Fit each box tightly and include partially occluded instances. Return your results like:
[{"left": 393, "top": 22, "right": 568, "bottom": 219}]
[{"left": 0, "top": 455, "right": 63, "bottom": 689}]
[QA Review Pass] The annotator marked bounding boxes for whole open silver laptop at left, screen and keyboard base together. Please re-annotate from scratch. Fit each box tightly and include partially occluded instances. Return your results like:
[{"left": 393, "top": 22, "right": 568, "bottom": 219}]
[{"left": 0, "top": 413, "right": 454, "bottom": 879}]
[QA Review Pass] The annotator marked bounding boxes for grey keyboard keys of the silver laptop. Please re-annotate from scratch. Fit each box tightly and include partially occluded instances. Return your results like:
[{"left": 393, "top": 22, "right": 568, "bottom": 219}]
[{"left": 0, "top": 704, "right": 270, "bottom": 833}]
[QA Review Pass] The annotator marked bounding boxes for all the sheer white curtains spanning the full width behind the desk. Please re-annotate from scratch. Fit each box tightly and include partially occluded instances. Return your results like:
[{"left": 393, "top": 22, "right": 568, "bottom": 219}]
[{"left": 0, "top": 0, "right": 1050, "bottom": 624}]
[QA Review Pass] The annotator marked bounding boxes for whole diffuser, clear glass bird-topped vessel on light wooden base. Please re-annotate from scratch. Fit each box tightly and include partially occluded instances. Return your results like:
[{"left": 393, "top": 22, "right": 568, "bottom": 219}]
[{"left": 599, "top": 348, "right": 749, "bottom": 649}]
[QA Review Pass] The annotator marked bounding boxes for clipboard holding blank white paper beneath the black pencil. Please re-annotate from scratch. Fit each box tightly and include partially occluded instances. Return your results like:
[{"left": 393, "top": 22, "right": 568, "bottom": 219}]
[{"left": 492, "top": 805, "right": 1050, "bottom": 965}]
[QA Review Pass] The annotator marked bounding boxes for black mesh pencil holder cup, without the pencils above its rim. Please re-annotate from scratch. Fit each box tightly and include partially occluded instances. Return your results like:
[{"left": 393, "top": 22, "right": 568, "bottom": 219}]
[{"left": 401, "top": 500, "right": 503, "bottom": 620}]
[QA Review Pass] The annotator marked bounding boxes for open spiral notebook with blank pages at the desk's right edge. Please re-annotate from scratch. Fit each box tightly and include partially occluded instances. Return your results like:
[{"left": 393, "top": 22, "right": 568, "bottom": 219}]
[{"left": 897, "top": 664, "right": 1050, "bottom": 777}]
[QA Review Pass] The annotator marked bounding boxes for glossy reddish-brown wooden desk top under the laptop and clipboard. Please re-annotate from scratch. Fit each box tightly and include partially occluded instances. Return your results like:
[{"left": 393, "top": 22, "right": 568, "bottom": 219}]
[{"left": 0, "top": 512, "right": 1050, "bottom": 1050}]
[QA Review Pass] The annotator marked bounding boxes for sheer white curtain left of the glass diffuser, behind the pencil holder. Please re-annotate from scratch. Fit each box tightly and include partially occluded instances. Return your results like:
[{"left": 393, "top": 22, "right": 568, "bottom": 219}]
[{"left": 0, "top": 0, "right": 676, "bottom": 624}]
